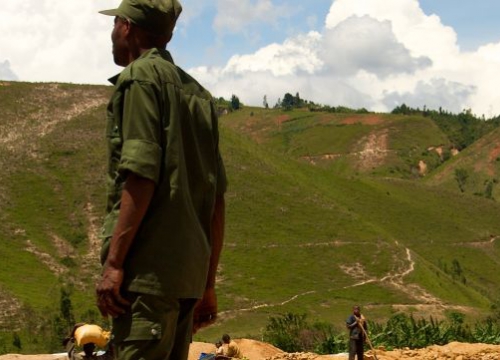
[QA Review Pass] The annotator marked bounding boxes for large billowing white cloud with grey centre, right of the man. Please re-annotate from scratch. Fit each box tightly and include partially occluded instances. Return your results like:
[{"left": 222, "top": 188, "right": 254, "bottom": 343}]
[{"left": 195, "top": 0, "right": 500, "bottom": 117}]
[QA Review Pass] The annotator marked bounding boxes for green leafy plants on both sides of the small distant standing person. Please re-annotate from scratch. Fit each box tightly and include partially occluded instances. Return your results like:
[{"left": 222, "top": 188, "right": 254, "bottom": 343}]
[{"left": 264, "top": 312, "right": 500, "bottom": 354}]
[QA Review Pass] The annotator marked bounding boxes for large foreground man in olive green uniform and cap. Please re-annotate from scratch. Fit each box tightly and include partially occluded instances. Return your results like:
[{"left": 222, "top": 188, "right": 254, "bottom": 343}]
[{"left": 96, "top": 0, "right": 226, "bottom": 360}]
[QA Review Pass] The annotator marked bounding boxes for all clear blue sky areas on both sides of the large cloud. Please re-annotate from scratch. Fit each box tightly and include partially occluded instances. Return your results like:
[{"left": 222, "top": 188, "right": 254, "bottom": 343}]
[{"left": 170, "top": 0, "right": 500, "bottom": 67}]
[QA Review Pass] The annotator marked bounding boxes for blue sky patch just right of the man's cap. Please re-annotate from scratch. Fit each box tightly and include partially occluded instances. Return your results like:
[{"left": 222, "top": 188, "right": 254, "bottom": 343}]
[{"left": 170, "top": 0, "right": 332, "bottom": 67}]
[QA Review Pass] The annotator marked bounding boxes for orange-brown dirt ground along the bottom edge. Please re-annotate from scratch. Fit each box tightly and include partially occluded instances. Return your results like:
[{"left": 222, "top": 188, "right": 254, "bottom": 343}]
[{"left": 0, "top": 339, "right": 500, "bottom": 360}]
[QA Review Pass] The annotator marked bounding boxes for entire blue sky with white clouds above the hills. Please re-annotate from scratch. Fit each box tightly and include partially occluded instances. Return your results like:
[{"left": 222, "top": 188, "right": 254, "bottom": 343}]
[{"left": 0, "top": 0, "right": 500, "bottom": 117}]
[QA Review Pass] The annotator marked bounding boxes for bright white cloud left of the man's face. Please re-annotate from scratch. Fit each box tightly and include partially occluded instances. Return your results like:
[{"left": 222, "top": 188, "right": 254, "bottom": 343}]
[{"left": 0, "top": 0, "right": 119, "bottom": 83}]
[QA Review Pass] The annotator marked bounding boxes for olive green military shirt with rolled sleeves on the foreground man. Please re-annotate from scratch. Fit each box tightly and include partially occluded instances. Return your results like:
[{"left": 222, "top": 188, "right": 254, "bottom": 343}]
[{"left": 101, "top": 49, "right": 226, "bottom": 298}]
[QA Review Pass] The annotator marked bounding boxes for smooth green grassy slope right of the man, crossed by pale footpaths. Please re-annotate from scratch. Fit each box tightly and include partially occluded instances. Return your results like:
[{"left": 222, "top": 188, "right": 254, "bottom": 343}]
[{"left": 196, "top": 110, "right": 500, "bottom": 336}]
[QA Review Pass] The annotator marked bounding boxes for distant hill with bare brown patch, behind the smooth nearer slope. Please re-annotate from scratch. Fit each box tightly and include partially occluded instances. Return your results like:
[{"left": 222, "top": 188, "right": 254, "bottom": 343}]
[{"left": 223, "top": 109, "right": 451, "bottom": 178}]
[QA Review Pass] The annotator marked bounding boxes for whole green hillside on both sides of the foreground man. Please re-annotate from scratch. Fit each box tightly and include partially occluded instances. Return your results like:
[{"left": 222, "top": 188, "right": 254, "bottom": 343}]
[{"left": 0, "top": 83, "right": 500, "bottom": 351}]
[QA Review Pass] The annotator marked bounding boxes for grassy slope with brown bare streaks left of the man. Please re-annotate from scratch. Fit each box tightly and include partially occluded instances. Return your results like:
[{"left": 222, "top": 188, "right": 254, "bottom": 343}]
[{"left": 0, "top": 83, "right": 109, "bottom": 318}]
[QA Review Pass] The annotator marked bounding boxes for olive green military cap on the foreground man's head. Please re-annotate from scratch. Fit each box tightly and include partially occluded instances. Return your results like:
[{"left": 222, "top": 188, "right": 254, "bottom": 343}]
[{"left": 99, "top": 0, "right": 182, "bottom": 35}]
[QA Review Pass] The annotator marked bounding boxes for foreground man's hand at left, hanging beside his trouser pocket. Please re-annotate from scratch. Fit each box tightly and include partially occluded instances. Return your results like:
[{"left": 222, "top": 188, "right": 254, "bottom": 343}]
[{"left": 96, "top": 265, "right": 130, "bottom": 317}]
